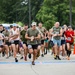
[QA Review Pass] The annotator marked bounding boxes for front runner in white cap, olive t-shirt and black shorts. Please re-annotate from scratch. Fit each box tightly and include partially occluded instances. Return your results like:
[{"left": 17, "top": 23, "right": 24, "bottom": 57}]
[{"left": 25, "top": 22, "right": 40, "bottom": 65}]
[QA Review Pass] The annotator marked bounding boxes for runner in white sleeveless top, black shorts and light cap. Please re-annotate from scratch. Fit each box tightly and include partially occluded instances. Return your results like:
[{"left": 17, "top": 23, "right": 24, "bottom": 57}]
[{"left": 9, "top": 24, "right": 20, "bottom": 62}]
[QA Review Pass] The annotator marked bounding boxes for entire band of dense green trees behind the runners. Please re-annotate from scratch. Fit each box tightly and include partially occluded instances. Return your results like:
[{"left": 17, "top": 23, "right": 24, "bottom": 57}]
[{"left": 0, "top": 0, "right": 75, "bottom": 29}]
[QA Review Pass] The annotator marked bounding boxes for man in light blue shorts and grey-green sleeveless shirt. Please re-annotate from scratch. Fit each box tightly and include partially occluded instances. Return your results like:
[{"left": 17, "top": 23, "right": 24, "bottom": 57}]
[{"left": 51, "top": 22, "right": 62, "bottom": 60}]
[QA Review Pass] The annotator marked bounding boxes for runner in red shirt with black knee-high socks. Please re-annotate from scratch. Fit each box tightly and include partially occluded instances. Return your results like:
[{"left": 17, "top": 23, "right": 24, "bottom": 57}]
[{"left": 65, "top": 26, "right": 74, "bottom": 60}]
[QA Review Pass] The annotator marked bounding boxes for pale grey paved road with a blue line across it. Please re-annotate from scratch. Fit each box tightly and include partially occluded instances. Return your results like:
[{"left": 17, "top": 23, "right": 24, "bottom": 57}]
[{"left": 0, "top": 53, "right": 75, "bottom": 75}]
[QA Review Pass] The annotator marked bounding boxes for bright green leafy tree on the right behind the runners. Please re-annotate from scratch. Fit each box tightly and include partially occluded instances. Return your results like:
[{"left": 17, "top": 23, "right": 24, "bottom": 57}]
[{"left": 36, "top": 0, "right": 75, "bottom": 29}]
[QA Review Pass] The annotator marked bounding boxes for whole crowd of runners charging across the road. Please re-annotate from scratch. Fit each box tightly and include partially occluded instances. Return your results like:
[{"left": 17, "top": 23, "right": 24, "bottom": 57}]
[{"left": 0, "top": 22, "right": 75, "bottom": 65}]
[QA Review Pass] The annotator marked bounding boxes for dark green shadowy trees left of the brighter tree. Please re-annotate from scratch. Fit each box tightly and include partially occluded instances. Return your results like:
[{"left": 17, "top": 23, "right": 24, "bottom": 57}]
[{"left": 0, "top": 0, "right": 43, "bottom": 23}]
